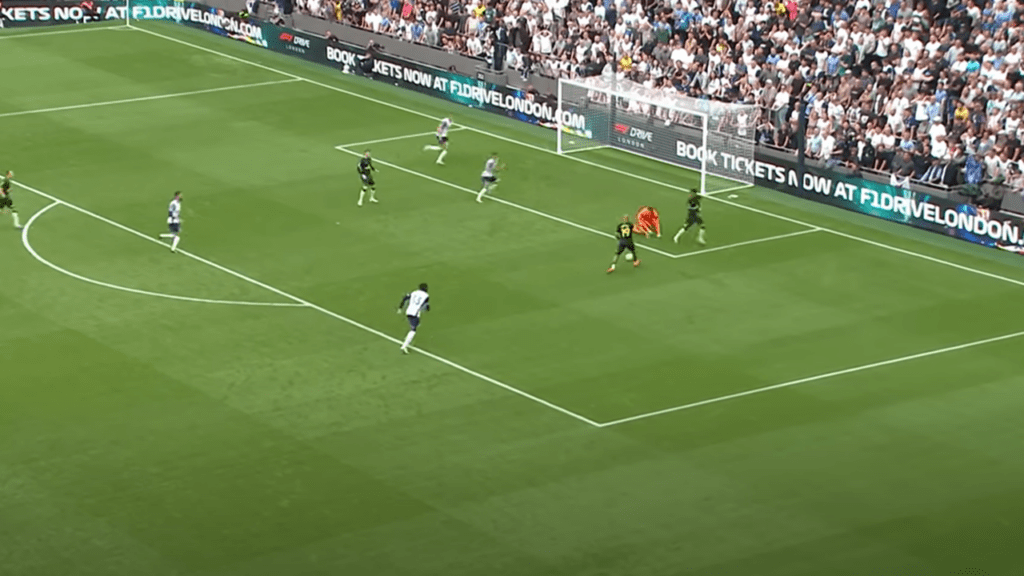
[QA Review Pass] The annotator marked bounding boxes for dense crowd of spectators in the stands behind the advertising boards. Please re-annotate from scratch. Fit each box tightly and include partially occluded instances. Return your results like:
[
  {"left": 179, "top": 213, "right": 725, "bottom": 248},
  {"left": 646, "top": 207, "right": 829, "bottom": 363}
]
[{"left": 296, "top": 0, "right": 1024, "bottom": 207}]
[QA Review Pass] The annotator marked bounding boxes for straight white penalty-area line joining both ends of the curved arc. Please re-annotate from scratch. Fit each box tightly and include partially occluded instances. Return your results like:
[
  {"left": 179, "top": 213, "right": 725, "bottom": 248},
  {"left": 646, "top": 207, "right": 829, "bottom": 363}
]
[{"left": 14, "top": 182, "right": 599, "bottom": 427}]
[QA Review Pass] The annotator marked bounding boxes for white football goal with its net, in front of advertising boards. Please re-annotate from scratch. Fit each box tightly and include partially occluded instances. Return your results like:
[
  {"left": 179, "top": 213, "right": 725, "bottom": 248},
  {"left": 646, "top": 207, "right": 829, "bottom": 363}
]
[{"left": 556, "top": 76, "right": 757, "bottom": 194}]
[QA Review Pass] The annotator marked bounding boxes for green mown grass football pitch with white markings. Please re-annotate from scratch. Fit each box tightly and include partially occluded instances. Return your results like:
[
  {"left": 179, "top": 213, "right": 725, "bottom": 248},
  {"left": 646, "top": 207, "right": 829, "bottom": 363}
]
[{"left": 0, "top": 19, "right": 1024, "bottom": 576}]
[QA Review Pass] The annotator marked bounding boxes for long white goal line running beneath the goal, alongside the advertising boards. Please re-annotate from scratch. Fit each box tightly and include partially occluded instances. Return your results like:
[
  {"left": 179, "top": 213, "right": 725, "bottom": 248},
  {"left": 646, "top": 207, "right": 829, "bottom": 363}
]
[{"left": 129, "top": 25, "right": 1024, "bottom": 286}]
